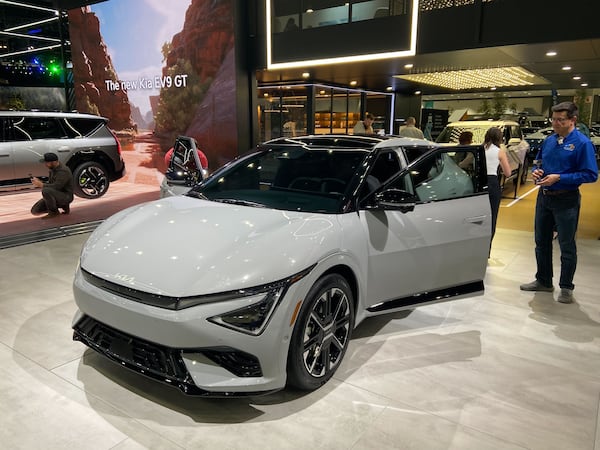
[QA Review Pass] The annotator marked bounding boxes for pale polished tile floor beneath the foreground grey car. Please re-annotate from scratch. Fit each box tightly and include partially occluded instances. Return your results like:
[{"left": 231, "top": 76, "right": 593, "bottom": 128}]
[{"left": 0, "top": 228, "right": 600, "bottom": 450}]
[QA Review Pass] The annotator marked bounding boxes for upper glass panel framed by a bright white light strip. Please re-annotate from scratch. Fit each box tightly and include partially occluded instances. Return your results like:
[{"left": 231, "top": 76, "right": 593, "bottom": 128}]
[{"left": 266, "top": 0, "right": 416, "bottom": 65}]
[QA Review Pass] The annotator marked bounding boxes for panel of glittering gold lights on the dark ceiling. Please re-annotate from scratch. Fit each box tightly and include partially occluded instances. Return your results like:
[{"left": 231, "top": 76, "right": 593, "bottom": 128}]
[{"left": 394, "top": 66, "right": 550, "bottom": 91}]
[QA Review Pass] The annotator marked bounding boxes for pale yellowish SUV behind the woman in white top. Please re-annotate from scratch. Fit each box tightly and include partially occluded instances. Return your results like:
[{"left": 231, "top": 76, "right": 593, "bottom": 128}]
[{"left": 436, "top": 120, "right": 529, "bottom": 198}]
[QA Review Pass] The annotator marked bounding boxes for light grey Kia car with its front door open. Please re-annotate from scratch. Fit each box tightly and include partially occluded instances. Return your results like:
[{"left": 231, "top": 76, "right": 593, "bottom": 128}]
[{"left": 72, "top": 138, "right": 491, "bottom": 396}]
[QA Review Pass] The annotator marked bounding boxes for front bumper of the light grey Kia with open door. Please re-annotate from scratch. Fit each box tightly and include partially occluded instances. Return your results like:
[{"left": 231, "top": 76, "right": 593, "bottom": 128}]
[{"left": 73, "top": 270, "right": 303, "bottom": 396}]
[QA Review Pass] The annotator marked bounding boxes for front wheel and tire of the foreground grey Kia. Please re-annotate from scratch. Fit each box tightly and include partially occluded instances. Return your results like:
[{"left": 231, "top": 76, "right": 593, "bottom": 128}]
[{"left": 287, "top": 274, "right": 354, "bottom": 391}]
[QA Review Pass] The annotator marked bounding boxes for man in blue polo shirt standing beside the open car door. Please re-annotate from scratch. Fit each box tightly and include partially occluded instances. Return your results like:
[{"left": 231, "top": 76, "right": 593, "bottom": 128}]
[{"left": 521, "top": 102, "right": 598, "bottom": 303}]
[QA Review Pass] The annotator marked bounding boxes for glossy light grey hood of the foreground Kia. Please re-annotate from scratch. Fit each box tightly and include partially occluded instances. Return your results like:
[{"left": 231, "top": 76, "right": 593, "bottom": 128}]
[{"left": 80, "top": 196, "right": 340, "bottom": 297}]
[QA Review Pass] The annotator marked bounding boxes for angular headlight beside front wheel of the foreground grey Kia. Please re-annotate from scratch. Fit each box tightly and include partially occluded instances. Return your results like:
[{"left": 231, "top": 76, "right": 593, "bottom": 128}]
[{"left": 208, "top": 266, "right": 314, "bottom": 336}]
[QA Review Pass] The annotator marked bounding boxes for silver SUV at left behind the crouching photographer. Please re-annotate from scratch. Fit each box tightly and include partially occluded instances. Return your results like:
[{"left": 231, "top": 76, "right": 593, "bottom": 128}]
[{"left": 0, "top": 111, "right": 125, "bottom": 198}]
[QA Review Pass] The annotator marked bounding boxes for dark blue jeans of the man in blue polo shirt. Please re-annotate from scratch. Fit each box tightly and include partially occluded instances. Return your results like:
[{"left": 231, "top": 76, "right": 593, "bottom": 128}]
[{"left": 535, "top": 189, "right": 581, "bottom": 289}]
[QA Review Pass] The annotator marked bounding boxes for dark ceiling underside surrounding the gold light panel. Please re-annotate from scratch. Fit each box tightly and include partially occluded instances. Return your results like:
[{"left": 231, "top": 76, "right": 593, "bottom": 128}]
[{"left": 258, "top": 39, "right": 600, "bottom": 95}]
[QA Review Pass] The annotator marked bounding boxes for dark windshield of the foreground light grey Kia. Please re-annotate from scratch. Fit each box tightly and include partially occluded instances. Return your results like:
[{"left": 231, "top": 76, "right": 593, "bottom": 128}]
[{"left": 187, "top": 145, "right": 369, "bottom": 213}]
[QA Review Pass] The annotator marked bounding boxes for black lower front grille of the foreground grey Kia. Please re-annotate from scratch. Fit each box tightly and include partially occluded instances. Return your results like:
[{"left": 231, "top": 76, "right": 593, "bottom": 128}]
[{"left": 73, "top": 316, "right": 266, "bottom": 396}]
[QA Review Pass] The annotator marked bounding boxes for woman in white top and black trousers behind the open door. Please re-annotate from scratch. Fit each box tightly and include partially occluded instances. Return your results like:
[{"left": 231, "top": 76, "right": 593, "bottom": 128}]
[{"left": 482, "top": 127, "right": 511, "bottom": 250}]
